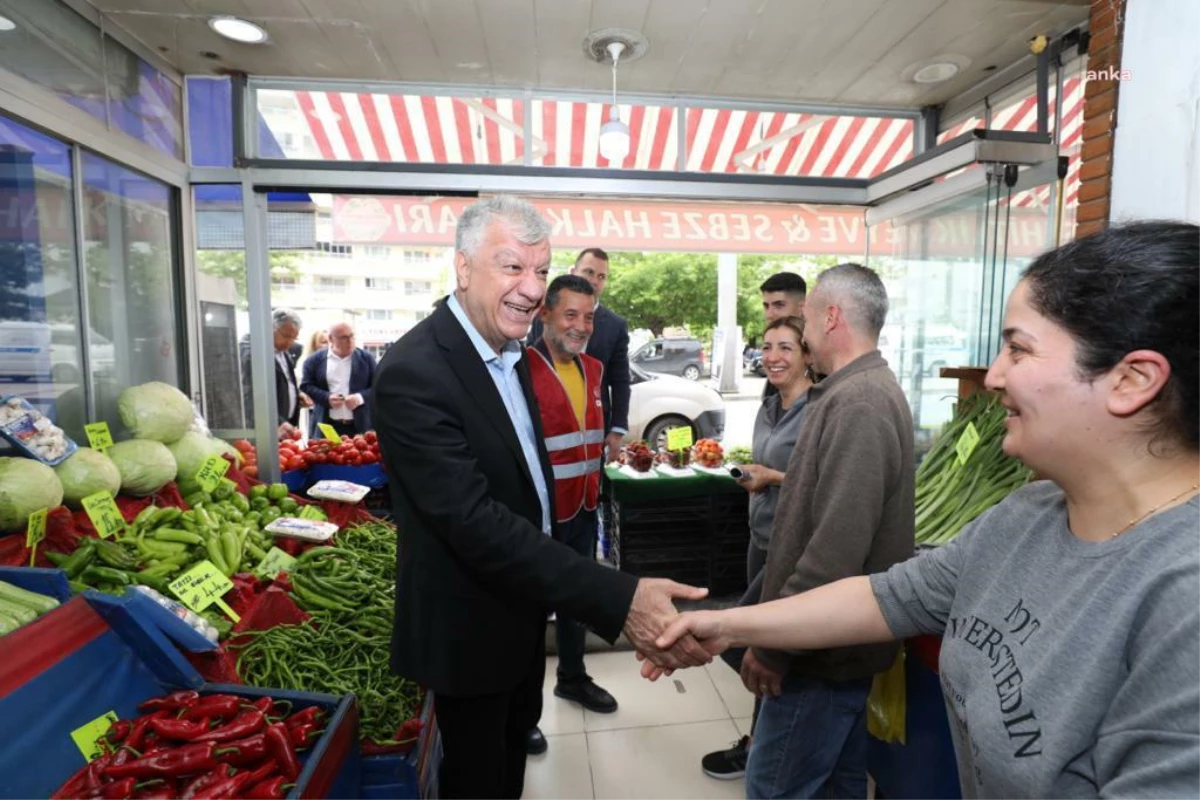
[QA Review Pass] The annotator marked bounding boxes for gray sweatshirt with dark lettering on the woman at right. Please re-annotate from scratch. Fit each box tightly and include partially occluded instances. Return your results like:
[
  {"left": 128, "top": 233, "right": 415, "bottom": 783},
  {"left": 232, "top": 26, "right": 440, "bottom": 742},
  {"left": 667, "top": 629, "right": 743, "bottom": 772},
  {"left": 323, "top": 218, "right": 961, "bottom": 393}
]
[{"left": 871, "top": 481, "right": 1200, "bottom": 800}]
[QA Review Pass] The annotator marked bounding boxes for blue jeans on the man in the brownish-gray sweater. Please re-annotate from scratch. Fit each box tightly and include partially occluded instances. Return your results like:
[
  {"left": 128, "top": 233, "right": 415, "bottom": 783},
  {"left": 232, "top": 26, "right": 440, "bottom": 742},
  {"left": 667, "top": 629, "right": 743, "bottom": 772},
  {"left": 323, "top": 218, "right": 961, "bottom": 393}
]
[{"left": 746, "top": 675, "right": 871, "bottom": 800}]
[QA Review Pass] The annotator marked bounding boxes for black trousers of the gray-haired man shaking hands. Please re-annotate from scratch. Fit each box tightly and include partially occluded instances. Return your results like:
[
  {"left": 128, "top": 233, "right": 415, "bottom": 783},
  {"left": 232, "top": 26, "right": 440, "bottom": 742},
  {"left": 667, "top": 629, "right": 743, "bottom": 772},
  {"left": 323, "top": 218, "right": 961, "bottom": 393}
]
[{"left": 433, "top": 637, "right": 546, "bottom": 800}]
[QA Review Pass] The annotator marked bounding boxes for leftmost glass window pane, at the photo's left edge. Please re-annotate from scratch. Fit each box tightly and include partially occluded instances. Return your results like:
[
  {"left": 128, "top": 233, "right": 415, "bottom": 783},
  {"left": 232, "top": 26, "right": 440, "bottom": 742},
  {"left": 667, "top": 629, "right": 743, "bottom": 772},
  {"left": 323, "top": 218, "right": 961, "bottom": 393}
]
[{"left": 0, "top": 110, "right": 86, "bottom": 438}]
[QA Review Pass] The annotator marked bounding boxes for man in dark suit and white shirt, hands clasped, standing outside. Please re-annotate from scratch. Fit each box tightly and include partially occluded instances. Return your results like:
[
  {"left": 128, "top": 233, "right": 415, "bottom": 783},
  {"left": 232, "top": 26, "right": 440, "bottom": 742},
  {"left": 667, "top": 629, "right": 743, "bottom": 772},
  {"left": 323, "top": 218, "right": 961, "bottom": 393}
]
[{"left": 300, "top": 323, "right": 376, "bottom": 439}]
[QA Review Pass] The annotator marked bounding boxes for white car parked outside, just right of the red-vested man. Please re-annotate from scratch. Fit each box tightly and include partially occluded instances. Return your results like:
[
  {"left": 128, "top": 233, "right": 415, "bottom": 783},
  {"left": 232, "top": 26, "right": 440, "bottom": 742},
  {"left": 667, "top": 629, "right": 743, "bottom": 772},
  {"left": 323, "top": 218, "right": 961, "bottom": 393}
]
[{"left": 628, "top": 363, "right": 725, "bottom": 449}]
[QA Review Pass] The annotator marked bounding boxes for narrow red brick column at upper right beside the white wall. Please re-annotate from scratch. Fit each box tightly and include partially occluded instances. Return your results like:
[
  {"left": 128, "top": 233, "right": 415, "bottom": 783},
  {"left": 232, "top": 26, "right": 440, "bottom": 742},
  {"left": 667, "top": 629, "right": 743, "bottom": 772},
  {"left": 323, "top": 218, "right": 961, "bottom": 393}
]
[{"left": 1075, "top": 0, "right": 1126, "bottom": 237}]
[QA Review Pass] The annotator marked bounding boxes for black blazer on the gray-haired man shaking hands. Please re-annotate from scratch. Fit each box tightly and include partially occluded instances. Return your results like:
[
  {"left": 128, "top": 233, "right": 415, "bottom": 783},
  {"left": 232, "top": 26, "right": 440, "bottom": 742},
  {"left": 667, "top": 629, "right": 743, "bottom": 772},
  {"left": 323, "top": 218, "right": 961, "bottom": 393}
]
[{"left": 371, "top": 306, "right": 637, "bottom": 696}]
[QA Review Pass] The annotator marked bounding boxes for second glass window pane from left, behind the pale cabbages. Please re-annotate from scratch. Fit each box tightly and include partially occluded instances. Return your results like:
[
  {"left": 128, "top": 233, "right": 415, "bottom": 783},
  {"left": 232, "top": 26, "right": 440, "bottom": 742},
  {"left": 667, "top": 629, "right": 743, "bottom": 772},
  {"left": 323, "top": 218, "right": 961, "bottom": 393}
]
[{"left": 83, "top": 152, "right": 182, "bottom": 432}]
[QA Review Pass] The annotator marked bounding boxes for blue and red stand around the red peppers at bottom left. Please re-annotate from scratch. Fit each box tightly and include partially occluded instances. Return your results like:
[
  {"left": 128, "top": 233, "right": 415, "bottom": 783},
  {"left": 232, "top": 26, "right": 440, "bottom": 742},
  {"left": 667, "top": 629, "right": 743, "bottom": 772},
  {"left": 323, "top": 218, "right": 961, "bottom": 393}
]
[{"left": 0, "top": 597, "right": 360, "bottom": 800}]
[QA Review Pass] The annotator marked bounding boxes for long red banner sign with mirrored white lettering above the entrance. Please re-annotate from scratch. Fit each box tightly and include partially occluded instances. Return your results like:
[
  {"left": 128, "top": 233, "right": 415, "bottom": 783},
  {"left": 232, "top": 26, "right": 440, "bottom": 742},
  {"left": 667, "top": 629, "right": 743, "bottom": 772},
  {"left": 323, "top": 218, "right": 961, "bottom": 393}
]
[{"left": 332, "top": 196, "right": 1049, "bottom": 258}]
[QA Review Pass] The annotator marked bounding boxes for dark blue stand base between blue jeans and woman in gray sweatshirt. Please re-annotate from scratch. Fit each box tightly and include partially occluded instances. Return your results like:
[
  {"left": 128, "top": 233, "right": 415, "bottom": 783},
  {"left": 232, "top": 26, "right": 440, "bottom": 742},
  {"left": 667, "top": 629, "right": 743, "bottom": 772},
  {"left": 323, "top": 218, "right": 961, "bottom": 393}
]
[{"left": 866, "top": 637, "right": 962, "bottom": 800}]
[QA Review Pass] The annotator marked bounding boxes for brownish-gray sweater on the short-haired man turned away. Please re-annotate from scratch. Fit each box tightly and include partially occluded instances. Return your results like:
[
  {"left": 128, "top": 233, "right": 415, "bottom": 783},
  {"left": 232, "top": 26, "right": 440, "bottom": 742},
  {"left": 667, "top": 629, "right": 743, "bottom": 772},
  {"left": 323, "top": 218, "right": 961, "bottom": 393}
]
[{"left": 755, "top": 350, "right": 914, "bottom": 681}]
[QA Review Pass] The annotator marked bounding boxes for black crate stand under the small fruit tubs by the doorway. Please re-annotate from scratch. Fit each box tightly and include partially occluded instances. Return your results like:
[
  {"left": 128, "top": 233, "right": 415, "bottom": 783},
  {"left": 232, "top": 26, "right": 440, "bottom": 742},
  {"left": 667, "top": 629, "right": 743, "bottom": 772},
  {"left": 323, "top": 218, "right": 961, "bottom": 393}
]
[{"left": 605, "top": 468, "right": 750, "bottom": 596}]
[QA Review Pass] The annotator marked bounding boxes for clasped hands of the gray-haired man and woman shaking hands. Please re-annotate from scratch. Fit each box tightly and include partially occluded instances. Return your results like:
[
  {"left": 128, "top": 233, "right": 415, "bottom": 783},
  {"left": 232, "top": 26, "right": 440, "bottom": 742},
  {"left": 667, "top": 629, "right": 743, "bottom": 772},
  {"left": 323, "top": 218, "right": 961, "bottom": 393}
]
[{"left": 624, "top": 578, "right": 732, "bottom": 680}]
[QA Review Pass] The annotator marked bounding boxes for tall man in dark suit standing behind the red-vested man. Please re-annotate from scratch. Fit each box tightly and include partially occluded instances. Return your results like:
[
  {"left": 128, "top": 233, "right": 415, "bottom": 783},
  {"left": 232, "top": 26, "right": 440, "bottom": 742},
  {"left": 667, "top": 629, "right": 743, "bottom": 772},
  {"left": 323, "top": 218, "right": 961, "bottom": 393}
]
[{"left": 528, "top": 247, "right": 630, "bottom": 461}]
